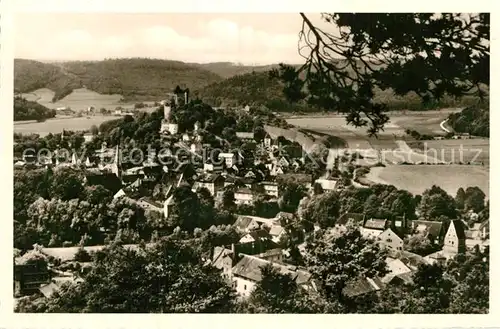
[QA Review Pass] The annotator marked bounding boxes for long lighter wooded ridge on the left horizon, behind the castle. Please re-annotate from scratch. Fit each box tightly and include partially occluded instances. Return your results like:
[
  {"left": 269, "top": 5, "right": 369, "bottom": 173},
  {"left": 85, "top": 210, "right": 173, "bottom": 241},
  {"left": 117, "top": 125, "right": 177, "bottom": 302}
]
[{"left": 14, "top": 58, "right": 223, "bottom": 100}]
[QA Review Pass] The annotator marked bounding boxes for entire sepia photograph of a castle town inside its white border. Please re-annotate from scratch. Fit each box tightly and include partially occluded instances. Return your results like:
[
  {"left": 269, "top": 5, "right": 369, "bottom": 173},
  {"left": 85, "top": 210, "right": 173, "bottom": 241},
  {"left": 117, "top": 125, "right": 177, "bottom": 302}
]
[{"left": 9, "top": 11, "right": 490, "bottom": 314}]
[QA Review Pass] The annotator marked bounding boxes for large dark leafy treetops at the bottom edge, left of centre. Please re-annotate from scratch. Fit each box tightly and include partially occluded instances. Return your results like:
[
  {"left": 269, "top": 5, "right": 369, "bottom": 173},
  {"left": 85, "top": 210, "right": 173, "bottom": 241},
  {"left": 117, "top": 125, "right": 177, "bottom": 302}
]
[{"left": 18, "top": 239, "right": 239, "bottom": 313}]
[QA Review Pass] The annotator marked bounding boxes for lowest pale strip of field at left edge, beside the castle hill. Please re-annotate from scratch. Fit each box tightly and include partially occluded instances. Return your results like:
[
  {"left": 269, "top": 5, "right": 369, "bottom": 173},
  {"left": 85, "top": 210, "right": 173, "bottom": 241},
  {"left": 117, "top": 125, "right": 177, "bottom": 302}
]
[{"left": 14, "top": 115, "right": 118, "bottom": 137}]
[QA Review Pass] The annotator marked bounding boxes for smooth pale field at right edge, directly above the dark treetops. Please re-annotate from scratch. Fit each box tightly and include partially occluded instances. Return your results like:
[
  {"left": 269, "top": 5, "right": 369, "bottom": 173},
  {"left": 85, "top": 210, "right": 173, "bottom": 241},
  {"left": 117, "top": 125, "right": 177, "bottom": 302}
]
[{"left": 365, "top": 165, "right": 489, "bottom": 198}]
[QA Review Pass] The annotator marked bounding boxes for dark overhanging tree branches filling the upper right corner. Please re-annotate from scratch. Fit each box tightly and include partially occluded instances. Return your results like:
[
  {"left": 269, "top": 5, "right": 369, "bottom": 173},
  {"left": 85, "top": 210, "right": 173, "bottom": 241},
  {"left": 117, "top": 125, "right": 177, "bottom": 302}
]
[{"left": 271, "top": 13, "right": 490, "bottom": 133}]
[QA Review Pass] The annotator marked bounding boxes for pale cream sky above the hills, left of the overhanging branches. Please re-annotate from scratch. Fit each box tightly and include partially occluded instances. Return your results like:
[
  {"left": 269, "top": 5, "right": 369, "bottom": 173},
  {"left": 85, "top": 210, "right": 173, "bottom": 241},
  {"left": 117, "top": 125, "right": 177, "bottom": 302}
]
[{"left": 14, "top": 12, "right": 328, "bottom": 65}]
